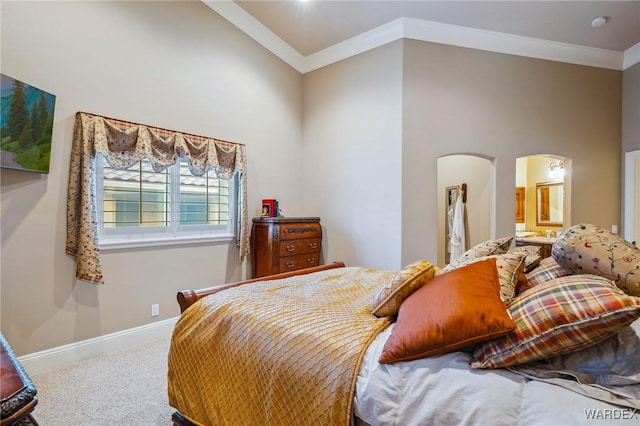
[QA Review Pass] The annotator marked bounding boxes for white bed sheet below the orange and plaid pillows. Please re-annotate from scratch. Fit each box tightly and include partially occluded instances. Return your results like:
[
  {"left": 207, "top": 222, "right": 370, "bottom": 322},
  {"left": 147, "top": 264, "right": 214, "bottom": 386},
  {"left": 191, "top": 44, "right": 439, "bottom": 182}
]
[{"left": 354, "top": 325, "right": 640, "bottom": 426}]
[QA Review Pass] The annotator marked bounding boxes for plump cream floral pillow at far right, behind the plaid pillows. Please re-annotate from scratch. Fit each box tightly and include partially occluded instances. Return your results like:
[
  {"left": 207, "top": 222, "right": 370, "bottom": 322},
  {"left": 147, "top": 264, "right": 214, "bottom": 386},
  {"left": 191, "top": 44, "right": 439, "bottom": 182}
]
[{"left": 551, "top": 223, "right": 640, "bottom": 296}]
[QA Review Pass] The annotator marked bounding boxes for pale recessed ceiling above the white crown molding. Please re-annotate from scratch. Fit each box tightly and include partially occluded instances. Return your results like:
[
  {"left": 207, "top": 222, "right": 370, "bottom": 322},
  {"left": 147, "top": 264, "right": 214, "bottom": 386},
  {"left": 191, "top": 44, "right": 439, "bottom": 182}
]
[{"left": 236, "top": 0, "right": 640, "bottom": 56}]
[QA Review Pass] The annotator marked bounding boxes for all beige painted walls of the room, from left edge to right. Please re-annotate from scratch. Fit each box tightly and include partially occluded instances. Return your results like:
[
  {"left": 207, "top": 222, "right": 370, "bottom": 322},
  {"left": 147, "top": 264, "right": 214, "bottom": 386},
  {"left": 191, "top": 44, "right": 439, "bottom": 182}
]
[{"left": 0, "top": 2, "right": 640, "bottom": 355}]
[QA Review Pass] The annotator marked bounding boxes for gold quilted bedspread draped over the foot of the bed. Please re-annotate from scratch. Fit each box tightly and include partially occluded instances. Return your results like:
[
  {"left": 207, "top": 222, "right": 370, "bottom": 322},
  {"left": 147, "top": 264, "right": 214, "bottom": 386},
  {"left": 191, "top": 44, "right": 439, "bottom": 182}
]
[{"left": 168, "top": 267, "right": 395, "bottom": 426}]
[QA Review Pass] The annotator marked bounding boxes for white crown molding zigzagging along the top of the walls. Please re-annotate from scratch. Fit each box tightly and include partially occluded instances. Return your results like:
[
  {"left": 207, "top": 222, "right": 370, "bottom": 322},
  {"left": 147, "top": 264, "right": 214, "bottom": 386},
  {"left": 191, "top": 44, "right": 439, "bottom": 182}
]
[{"left": 202, "top": 0, "right": 640, "bottom": 74}]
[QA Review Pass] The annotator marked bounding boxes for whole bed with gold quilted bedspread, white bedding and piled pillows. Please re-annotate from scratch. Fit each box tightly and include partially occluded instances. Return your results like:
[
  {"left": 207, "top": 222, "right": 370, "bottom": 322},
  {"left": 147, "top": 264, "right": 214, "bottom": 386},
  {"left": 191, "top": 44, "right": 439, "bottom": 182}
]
[{"left": 168, "top": 224, "right": 640, "bottom": 426}]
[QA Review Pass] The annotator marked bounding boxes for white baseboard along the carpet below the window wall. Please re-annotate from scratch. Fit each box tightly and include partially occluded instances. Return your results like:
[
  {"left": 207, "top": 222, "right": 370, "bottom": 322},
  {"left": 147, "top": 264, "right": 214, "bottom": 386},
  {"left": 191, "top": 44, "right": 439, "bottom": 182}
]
[{"left": 18, "top": 317, "right": 178, "bottom": 375}]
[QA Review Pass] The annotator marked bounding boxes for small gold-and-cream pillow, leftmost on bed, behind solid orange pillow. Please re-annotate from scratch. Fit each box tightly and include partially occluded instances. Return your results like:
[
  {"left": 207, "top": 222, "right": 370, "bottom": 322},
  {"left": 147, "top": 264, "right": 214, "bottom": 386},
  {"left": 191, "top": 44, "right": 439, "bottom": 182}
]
[{"left": 371, "top": 260, "right": 439, "bottom": 317}]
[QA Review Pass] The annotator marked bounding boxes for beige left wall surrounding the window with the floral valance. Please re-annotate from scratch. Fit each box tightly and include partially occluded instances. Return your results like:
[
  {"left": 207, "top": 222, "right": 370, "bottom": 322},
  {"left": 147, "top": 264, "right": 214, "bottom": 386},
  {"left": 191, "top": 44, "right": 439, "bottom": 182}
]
[{"left": 0, "top": 1, "right": 303, "bottom": 355}]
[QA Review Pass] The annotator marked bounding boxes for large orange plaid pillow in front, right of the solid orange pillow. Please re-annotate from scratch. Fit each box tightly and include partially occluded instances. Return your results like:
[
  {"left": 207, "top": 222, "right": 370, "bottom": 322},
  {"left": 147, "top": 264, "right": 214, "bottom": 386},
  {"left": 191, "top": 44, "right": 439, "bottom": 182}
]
[{"left": 469, "top": 274, "right": 640, "bottom": 368}]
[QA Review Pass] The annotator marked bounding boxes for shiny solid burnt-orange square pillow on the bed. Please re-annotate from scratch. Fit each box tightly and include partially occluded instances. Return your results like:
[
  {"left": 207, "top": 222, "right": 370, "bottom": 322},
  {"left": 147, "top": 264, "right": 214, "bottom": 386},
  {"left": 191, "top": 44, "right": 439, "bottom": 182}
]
[{"left": 379, "top": 258, "right": 516, "bottom": 364}]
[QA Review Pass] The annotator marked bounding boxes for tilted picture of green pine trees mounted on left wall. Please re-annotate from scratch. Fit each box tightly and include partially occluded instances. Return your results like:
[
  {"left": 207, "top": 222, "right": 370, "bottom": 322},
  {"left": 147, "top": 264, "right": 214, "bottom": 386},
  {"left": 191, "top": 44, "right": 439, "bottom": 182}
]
[{"left": 0, "top": 74, "right": 56, "bottom": 173}]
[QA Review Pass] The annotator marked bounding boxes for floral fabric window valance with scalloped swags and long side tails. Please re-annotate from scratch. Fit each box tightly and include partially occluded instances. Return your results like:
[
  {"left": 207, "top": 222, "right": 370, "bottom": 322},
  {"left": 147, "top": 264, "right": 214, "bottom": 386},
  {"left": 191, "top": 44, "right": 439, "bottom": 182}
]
[{"left": 65, "top": 112, "right": 249, "bottom": 284}]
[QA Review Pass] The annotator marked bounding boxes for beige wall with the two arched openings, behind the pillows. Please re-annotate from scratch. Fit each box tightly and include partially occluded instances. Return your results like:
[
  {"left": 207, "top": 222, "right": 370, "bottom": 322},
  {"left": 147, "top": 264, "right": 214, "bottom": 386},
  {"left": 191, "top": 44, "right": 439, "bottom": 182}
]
[{"left": 402, "top": 40, "right": 622, "bottom": 263}]
